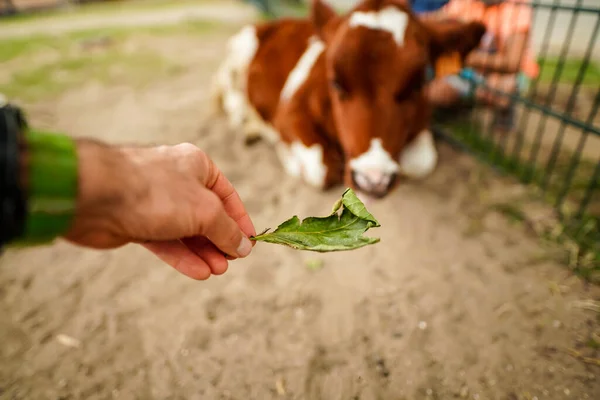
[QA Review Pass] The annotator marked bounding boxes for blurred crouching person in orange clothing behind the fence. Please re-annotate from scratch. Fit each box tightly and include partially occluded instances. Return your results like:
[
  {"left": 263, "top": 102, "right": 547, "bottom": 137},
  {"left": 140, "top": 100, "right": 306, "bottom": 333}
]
[{"left": 424, "top": 0, "right": 539, "bottom": 131}]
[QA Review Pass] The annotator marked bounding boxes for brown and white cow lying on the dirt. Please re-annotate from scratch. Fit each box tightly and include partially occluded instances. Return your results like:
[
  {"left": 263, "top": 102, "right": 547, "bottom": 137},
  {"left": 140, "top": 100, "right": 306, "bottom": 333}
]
[{"left": 215, "top": 0, "right": 485, "bottom": 198}]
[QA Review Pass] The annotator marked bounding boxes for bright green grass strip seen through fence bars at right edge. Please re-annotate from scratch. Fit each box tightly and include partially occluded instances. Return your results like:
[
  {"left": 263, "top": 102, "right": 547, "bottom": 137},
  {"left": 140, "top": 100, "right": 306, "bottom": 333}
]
[{"left": 538, "top": 58, "right": 600, "bottom": 86}]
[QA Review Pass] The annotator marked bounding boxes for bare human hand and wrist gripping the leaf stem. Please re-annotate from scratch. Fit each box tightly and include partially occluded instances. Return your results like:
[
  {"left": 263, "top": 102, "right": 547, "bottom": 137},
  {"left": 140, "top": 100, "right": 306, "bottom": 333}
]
[{"left": 65, "top": 140, "right": 256, "bottom": 280}]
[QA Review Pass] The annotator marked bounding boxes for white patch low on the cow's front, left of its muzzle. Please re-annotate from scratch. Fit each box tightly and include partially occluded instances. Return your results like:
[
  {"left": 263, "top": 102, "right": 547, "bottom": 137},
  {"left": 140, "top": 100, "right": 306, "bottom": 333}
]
[{"left": 275, "top": 142, "right": 327, "bottom": 188}]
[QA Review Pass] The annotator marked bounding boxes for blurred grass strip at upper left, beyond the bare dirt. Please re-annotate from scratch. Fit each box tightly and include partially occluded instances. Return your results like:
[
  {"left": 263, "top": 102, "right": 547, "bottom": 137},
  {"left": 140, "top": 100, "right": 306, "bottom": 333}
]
[{"left": 0, "top": 20, "right": 232, "bottom": 101}]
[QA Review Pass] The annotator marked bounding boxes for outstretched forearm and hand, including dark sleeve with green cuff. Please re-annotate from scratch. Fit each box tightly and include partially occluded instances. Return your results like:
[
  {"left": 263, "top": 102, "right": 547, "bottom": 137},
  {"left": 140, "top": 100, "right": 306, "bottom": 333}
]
[{"left": 0, "top": 94, "right": 256, "bottom": 280}]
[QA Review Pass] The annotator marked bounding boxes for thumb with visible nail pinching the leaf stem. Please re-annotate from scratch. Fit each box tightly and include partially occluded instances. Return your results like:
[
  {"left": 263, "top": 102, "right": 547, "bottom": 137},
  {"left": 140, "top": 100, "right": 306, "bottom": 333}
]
[{"left": 200, "top": 190, "right": 252, "bottom": 258}]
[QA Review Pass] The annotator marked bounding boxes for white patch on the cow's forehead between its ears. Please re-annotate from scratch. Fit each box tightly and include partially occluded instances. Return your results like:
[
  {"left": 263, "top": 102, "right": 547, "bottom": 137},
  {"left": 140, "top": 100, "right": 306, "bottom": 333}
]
[{"left": 349, "top": 6, "right": 408, "bottom": 46}]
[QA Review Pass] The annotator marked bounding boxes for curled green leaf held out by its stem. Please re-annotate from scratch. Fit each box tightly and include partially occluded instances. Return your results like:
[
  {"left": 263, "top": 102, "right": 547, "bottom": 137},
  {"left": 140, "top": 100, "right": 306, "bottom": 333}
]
[{"left": 251, "top": 189, "right": 381, "bottom": 252}]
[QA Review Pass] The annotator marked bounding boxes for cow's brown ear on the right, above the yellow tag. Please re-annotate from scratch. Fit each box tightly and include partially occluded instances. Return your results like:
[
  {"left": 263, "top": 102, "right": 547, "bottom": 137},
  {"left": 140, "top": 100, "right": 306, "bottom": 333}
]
[{"left": 423, "top": 20, "right": 486, "bottom": 60}]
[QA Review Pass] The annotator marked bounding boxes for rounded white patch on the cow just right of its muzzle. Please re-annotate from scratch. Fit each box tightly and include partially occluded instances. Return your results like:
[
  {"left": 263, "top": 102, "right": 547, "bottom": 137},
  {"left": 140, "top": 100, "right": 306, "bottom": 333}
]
[{"left": 400, "top": 130, "right": 438, "bottom": 179}]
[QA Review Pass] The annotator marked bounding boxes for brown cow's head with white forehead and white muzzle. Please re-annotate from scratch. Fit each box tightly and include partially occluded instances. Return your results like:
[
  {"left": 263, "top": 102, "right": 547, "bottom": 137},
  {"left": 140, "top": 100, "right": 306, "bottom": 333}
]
[{"left": 311, "top": 0, "right": 485, "bottom": 197}]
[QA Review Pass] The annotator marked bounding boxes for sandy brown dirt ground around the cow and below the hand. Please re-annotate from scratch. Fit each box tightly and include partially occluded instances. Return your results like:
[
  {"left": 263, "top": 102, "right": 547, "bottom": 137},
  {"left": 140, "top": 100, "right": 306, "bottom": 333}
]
[{"left": 0, "top": 6, "right": 600, "bottom": 400}]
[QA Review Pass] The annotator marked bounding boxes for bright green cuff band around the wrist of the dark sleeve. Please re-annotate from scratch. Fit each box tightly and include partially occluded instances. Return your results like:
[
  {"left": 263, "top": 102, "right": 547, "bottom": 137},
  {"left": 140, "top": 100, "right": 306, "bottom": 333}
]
[{"left": 11, "top": 130, "right": 78, "bottom": 246}]
